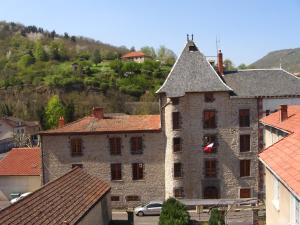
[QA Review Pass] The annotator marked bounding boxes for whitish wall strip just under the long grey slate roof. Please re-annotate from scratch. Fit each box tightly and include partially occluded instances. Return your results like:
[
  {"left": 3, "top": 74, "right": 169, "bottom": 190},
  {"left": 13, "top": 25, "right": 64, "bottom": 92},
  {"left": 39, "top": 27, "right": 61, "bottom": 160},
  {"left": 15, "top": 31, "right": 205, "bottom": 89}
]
[{"left": 263, "top": 97, "right": 300, "bottom": 116}]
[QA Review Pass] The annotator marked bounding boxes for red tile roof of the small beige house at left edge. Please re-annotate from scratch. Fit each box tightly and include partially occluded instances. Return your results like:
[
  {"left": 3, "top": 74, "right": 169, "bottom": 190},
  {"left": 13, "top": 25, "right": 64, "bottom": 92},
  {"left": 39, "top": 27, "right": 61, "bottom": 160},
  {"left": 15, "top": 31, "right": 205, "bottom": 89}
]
[{"left": 0, "top": 148, "right": 41, "bottom": 176}]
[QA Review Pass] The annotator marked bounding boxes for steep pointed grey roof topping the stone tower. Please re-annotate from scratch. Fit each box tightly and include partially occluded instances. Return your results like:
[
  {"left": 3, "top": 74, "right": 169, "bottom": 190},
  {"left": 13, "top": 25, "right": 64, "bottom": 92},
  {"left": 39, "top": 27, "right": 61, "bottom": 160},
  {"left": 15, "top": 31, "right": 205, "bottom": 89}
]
[{"left": 156, "top": 40, "right": 232, "bottom": 97}]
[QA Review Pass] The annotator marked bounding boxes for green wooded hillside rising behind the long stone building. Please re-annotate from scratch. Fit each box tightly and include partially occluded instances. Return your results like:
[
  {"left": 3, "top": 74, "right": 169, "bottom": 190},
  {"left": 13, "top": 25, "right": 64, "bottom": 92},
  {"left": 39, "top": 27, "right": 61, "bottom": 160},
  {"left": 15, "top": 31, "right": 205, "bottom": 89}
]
[{"left": 0, "top": 22, "right": 176, "bottom": 126}]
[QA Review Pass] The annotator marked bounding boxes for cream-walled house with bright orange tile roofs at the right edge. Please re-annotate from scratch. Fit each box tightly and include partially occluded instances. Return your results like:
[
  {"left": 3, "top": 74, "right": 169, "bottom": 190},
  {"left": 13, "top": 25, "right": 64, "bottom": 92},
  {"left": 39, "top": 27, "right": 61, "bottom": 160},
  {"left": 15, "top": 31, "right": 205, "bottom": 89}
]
[{"left": 259, "top": 105, "right": 300, "bottom": 225}]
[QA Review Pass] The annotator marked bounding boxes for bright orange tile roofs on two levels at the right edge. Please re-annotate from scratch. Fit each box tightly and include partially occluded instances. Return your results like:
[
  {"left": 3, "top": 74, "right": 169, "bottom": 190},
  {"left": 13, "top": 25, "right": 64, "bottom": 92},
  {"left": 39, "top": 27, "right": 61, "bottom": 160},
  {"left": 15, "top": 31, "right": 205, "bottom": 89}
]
[{"left": 259, "top": 106, "right": 300, "bottom": 196}]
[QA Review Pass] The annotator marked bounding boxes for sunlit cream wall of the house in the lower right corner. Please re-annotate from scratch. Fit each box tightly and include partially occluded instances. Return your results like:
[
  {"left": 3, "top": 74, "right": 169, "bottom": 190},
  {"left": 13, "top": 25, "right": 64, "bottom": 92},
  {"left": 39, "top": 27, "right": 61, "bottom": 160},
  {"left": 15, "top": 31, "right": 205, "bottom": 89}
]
[{"left": 265, "top": 169, "right": 292, "bottom": 225}]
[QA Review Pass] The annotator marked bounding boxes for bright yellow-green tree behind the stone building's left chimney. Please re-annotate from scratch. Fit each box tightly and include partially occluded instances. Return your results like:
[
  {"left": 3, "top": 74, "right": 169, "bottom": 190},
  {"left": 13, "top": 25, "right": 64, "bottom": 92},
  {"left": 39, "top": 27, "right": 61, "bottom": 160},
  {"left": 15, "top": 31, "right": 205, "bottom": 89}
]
[{"left": 45, "top": 95, "right": 64, "bottom": 128}]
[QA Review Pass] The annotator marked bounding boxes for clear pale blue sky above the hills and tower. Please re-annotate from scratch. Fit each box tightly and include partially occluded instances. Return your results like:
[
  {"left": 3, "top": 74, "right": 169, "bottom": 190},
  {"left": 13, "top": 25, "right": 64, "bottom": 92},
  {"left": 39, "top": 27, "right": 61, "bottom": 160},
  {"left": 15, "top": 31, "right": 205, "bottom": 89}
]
[{"left": 0, "top": 0, "right": 300, "bottom": 65}]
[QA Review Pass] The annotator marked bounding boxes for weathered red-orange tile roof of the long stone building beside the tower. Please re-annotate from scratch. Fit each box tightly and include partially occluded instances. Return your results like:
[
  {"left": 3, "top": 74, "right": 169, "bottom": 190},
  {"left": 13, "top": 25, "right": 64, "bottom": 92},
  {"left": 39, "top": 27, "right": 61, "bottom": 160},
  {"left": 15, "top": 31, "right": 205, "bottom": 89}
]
[{"left": 40, "top": 115, "right": 161, "bottom": 135}]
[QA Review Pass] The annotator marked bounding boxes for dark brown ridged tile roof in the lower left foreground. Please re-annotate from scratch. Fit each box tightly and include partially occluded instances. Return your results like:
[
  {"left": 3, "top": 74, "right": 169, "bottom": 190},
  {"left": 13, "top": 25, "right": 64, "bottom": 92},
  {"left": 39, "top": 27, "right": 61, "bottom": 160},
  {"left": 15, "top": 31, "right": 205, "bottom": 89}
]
[{"left": 0, "top": 167, "right": 110, "bottom": 225}]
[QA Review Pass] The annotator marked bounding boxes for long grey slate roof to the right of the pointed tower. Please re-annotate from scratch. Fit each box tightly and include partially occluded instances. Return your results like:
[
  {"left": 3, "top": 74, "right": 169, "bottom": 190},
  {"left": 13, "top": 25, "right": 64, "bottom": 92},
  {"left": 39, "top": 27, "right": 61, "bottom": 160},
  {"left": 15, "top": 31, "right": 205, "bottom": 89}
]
[{"left": 224, "top": 69, "right": 300, "bottom": 97}]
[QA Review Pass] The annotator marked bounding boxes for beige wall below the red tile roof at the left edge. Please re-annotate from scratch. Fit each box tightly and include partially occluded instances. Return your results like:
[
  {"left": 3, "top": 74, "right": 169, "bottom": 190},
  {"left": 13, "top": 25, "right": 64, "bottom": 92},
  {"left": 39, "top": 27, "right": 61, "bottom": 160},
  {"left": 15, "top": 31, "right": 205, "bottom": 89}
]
[{"left": 0, "top": 176, "right": 41, "bottom": 201}]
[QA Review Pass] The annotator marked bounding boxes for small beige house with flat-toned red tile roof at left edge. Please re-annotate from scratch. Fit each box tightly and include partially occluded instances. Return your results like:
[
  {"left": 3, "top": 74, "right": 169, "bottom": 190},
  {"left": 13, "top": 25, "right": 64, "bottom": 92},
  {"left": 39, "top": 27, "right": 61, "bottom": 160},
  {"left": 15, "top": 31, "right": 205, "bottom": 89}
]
[{"left": 0, "top": 148, "right": 41, "bottom": 201}]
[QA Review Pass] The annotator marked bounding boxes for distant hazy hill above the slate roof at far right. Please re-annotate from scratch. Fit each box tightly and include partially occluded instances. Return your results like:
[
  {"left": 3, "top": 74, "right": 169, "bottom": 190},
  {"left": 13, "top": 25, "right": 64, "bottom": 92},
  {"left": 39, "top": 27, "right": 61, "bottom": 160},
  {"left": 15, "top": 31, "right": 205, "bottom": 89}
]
[{"left": 250, "top": 48, "right": 300, "bottom": 73}]
